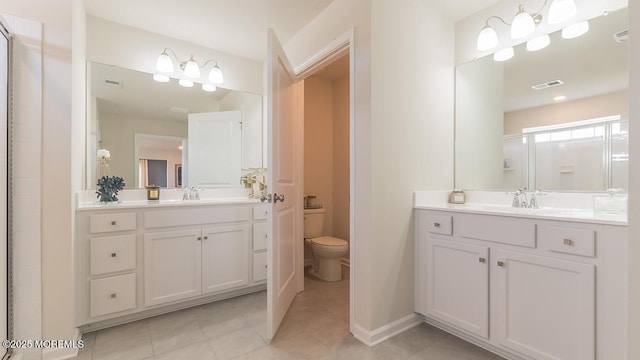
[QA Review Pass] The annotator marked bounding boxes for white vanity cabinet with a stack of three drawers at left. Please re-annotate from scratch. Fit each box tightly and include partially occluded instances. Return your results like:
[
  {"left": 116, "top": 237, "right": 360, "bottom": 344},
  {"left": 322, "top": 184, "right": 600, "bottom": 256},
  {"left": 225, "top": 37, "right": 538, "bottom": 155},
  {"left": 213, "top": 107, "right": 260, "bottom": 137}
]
[{"left": 75, "top": 203, "right": 269, "bottom": 329}]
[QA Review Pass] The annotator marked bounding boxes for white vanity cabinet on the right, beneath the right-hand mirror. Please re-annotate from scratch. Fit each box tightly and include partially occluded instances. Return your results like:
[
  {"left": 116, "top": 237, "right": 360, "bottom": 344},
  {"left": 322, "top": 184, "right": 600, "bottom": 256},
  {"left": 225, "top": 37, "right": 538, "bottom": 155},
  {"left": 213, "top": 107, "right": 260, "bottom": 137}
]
[{"left": 415, "top": 209, "right": 627, "bottom": 360}]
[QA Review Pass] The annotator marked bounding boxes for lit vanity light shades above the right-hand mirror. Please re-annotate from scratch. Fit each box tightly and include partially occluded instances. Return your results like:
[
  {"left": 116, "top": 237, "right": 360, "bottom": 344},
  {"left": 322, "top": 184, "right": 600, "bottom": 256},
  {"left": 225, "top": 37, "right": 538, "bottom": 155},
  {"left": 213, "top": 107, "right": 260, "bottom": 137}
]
[{"left": 476, "top": 0, "right": 577, "bottom": 61}]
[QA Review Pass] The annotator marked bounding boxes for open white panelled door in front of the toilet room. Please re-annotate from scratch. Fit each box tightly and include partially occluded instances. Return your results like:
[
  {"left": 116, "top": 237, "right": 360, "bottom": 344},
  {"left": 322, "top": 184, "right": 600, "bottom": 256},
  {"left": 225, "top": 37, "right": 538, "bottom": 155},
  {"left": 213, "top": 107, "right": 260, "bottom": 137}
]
[{"left": 267, "top": 30, "right": 303, "bottom": 338}]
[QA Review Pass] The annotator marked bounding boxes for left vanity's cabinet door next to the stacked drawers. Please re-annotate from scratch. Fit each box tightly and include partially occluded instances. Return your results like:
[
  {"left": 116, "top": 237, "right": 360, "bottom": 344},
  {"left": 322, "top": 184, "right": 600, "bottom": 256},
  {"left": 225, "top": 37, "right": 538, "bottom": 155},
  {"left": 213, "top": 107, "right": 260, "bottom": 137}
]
[{"left": 144, "top": 228, "right": 202, "bottom": 306}]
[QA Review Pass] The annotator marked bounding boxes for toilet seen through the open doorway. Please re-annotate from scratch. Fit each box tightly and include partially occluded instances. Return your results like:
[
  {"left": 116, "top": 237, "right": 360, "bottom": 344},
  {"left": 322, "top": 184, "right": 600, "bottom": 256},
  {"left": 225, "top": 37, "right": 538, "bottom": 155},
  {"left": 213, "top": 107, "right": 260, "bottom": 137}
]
[{"left": 304, "top": 208, "right": 349, "bottom": 281}]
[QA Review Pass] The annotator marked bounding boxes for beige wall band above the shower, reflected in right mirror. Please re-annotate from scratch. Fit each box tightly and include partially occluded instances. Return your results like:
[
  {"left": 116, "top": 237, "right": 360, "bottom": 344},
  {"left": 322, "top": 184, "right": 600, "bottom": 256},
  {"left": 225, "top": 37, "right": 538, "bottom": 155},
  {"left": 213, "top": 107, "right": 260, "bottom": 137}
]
[{"left": 504, "top": 90, "right": 629, "bottom": 135}]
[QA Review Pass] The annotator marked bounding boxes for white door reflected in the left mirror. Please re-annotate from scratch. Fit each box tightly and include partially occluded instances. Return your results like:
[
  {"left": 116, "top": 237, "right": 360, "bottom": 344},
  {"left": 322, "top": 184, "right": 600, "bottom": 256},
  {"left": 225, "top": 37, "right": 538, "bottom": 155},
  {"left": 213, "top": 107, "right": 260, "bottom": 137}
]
[{"left": 189, "top": 111, "right": 242, "bottom": 188}]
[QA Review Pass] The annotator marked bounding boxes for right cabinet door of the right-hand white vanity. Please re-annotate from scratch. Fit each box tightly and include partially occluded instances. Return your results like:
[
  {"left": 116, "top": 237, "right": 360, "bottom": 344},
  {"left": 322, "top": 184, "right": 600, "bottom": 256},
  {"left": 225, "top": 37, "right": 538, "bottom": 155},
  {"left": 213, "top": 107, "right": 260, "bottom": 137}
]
[{"left": 491, "top": 250, "right": 595, "bottom": 360}]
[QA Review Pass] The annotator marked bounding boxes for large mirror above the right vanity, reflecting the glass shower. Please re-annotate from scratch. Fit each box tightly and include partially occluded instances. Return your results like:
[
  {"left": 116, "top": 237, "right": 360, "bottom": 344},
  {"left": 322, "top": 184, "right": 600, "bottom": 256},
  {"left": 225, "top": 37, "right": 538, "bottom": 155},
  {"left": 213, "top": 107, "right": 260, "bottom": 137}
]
[{"left": 455, "top": 8, "right": 628, "bottom": 191}]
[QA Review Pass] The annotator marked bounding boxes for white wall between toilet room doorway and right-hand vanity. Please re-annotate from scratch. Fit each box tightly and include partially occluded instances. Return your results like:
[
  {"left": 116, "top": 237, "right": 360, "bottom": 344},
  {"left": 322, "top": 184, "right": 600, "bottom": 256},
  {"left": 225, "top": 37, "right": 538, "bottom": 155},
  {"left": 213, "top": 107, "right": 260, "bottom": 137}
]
[{"left": 370, "top": 0, "right": 454, "bottom": 329}]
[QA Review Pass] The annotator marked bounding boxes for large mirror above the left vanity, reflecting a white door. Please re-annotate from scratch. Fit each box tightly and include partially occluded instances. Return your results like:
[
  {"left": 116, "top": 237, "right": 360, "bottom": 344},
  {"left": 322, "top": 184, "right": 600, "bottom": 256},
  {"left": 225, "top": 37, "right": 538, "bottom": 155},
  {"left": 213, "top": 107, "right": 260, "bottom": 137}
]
[{"left": 86, "top": 62, "right": 263, "bottom": 189}]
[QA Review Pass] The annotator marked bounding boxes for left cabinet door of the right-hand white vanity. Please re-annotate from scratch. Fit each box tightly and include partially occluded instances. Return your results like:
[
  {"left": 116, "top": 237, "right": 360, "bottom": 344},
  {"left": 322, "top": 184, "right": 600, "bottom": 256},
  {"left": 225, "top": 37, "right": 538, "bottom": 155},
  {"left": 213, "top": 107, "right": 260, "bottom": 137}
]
[{"left": 426, "top": 237, "right": 489, "bottom": 338}]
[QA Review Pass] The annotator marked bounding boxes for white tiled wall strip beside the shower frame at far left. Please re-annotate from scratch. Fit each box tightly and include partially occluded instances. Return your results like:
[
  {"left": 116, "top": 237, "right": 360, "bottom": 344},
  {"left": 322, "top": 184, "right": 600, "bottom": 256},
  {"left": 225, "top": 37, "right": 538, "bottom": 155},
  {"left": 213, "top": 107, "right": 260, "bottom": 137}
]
[{"left": 3, "top": 15, "right": 42, "bottom": 359}]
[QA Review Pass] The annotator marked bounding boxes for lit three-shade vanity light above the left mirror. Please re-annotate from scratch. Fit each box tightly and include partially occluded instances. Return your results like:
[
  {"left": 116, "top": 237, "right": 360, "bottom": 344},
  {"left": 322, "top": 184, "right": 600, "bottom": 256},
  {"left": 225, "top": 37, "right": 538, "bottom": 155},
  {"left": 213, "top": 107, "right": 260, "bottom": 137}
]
[{"left": 153, "top": 48, "right": 224, "bottom": 91}]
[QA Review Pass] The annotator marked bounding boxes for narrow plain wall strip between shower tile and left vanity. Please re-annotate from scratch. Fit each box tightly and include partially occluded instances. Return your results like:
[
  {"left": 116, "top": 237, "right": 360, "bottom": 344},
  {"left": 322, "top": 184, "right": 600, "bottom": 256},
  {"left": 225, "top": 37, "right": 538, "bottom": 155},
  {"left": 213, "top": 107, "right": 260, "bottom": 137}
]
[{"left": 0, "top": 0, "right": 82, "bottom": 357}]
